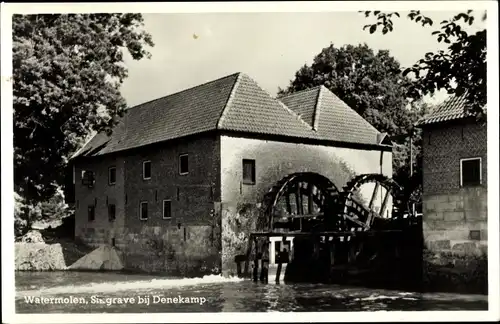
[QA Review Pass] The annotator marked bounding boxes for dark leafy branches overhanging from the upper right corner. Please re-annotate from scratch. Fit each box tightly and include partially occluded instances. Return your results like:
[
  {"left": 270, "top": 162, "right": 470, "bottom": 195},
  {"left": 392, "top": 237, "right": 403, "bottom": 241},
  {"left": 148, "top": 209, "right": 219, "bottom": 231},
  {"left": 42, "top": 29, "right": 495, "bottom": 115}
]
[{"left": 363, "top": 10, "right": 487, "bottom": 117}]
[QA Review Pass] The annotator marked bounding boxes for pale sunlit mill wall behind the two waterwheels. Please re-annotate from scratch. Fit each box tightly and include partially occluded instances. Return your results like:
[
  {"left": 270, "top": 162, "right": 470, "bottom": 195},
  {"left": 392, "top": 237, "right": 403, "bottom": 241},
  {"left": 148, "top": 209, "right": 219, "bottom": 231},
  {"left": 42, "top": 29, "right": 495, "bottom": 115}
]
[{"left": 220, "top": 136, "right": 392, "bottom": 274}]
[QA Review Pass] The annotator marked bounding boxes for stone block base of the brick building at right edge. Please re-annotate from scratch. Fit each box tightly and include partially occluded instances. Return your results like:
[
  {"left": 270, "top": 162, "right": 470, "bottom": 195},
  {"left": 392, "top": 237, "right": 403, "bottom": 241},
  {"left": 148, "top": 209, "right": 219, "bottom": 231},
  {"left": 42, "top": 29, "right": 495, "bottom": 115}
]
[{"left": 423, "top": 187, "right": 488, "bottom": 293}]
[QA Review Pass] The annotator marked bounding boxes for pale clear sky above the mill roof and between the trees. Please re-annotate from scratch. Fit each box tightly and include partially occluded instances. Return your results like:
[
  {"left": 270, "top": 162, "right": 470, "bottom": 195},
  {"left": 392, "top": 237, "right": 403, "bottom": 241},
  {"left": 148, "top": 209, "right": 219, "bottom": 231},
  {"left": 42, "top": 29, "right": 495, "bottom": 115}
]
[{"left": 122, "top": 11, "right": 481, "bottom": 106}]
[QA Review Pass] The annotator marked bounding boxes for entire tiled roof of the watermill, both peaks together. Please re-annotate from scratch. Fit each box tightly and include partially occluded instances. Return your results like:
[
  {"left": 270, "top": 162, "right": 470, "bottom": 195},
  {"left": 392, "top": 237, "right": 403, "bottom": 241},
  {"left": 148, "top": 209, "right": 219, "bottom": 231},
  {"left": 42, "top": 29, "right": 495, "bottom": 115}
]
[{"left": 73, "top": 73, "right": 379, "bottom": 157}]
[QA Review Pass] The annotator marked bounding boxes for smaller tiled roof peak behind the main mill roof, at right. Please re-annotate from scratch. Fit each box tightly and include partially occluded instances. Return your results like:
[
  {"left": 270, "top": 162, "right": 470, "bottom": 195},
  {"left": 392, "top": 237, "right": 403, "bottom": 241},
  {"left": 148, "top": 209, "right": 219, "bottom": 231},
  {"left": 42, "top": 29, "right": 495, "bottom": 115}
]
[{"left": 280, "top": 86, "right": 380, "bottom": 144}]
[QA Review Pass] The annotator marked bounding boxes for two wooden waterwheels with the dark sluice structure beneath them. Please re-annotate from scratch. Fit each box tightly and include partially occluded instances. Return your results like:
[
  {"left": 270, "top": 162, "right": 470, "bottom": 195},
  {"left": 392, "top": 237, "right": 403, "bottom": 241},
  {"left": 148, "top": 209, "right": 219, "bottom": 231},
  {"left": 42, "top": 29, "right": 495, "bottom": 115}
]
[{"left": 235, "top": 173, "right": 423, "bottom": 287}]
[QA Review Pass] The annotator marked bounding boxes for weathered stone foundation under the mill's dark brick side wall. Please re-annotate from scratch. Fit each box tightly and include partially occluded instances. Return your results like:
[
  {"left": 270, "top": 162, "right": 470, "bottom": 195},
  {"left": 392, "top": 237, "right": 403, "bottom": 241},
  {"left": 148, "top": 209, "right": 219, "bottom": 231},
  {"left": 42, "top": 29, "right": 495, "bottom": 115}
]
[{"left": 78, "top": 225, "right": 221, "bottom": 276}]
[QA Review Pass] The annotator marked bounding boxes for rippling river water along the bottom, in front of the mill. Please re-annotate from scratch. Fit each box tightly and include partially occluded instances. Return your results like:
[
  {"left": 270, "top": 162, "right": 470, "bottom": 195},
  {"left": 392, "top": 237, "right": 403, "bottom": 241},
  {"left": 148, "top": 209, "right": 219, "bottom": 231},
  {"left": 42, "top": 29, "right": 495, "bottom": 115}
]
[{"left": 15, "top": 271, "right": 488, "bottom": 313}]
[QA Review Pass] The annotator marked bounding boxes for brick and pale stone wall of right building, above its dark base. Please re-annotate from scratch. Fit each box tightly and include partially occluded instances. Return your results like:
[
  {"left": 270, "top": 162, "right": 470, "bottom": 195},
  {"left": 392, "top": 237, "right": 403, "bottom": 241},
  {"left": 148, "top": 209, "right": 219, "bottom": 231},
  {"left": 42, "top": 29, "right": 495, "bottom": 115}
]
[{"left": 423, "top": 122, "right": 487, "bottom": 253}]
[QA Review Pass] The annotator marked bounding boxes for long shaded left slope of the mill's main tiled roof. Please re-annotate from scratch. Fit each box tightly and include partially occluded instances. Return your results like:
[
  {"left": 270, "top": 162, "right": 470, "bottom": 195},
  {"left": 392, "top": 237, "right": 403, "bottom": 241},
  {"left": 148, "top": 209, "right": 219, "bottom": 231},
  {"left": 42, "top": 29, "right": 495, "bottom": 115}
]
[{"left": 75, "top": 73, "right": 239, "bottom": 156}]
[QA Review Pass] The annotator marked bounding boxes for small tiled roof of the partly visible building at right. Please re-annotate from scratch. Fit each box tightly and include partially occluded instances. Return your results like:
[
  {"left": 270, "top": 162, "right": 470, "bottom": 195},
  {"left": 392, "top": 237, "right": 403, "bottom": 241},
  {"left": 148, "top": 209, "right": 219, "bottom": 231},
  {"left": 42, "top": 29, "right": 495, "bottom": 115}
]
[{"left": 417, "top": 95, "right": 471, "bottom": 126}]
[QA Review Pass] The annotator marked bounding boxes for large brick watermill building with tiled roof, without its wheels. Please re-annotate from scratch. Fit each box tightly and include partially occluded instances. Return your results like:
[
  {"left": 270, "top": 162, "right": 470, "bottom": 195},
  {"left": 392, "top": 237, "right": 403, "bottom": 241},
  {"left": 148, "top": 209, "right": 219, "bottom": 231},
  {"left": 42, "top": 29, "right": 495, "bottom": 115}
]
[{"left": 69, "top": 73, "right": 394, "bottom": 273}]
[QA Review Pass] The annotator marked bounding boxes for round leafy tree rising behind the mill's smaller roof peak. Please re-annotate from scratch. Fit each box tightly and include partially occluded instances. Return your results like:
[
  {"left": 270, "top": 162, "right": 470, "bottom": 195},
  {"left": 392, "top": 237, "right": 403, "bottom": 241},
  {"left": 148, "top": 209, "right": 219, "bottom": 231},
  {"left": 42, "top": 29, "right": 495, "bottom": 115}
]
[{"left": 278, "top": 44, "right": 428, "bottom": 211}]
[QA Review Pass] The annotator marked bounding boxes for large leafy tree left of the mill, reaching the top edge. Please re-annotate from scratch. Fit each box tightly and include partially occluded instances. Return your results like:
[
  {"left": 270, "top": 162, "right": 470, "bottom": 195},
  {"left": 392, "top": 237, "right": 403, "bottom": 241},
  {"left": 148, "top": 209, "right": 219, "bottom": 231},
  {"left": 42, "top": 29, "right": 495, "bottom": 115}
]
[{"left": 12, "top": 14, "right": 154, "bottom": 233}]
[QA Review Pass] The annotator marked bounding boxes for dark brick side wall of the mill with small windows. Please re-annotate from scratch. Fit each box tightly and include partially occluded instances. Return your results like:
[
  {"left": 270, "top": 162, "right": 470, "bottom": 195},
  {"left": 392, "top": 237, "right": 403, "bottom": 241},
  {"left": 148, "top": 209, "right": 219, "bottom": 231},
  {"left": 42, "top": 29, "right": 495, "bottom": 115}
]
[{"left": 75, "top": 135, "right": 220, "bottom": 273}]
